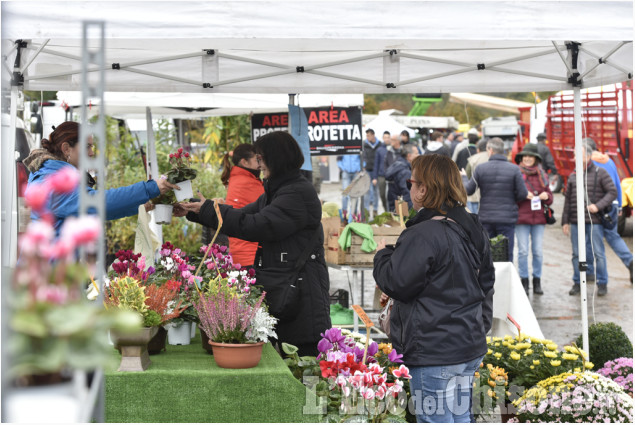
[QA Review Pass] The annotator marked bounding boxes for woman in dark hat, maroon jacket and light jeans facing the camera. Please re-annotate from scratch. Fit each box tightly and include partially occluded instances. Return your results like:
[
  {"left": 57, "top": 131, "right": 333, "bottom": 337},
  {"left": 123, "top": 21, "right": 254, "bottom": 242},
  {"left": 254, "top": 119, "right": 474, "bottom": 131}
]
[{"left": 515, "top": 143, "right": 553, "bottom": 295}]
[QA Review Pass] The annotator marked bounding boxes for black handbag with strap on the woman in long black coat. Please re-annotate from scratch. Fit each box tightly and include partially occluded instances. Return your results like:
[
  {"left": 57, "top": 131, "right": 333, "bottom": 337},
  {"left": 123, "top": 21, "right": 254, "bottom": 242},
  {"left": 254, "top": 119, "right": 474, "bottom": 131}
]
[{"left": 256, "top": 226, "right": 322, "bottom": 321}]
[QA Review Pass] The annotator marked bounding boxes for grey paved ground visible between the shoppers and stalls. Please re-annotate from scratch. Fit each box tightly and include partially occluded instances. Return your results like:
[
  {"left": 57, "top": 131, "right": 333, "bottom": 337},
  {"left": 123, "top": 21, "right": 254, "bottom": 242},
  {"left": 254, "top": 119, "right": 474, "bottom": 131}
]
[{"left": 320, "top": 183, "right": 633, "bottom": 347}]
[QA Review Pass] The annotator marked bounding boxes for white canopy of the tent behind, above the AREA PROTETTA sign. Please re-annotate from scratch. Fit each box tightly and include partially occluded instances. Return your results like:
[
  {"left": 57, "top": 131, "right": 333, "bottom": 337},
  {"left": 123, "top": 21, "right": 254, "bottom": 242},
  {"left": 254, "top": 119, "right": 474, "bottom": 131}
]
[{"left": 52, "top": 91, "right": 364, "bottom": 119}]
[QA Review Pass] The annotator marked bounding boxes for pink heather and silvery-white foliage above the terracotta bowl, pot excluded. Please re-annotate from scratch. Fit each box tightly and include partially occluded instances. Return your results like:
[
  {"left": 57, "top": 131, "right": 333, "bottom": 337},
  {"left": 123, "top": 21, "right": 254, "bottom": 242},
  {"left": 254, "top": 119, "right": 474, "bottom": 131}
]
[{"left": 193, "top": 282, "right": 277, "bottom": 344}]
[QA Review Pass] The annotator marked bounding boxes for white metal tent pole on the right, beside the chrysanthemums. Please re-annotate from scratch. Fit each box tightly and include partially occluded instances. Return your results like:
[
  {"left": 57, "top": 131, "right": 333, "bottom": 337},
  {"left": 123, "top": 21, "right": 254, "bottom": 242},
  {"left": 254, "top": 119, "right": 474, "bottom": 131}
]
[{"left": 573, "top": 86, "right": 593, "bottom": 354}]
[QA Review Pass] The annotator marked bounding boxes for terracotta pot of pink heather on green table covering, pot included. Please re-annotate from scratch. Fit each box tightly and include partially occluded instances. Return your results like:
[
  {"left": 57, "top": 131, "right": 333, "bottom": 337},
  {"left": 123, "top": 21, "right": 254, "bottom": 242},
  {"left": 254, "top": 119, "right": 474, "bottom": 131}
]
[{"left": 193, "top": 280, "right": 277, "bottom": 369}]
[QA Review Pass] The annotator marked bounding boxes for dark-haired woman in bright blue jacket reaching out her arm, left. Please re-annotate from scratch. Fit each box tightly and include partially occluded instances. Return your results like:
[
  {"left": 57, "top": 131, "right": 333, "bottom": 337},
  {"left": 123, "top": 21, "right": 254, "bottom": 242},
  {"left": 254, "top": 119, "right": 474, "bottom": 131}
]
[{"left": 24, "top": 121, "right": 178, "bottom": 235}]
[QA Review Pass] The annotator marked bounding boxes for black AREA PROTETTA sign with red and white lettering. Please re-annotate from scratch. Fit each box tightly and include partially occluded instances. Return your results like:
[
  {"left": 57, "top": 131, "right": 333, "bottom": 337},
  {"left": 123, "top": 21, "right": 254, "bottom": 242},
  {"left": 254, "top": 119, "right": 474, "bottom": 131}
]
[{"left": 251, "top": 106, "right": 363, "bottom": 155}]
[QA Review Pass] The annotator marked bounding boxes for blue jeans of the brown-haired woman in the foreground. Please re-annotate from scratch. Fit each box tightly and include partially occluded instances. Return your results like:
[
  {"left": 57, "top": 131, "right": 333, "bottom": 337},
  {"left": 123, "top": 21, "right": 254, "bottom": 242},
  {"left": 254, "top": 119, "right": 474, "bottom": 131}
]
[{"left": 409, "top": 356, "right": 483, "bottom": 423}]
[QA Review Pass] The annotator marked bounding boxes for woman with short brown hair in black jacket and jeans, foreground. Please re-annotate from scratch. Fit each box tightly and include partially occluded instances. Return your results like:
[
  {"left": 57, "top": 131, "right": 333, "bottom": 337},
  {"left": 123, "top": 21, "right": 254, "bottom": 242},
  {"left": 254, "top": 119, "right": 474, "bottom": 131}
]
[{"left": 373, "top": 154, "right": 495, "bottom": 423}]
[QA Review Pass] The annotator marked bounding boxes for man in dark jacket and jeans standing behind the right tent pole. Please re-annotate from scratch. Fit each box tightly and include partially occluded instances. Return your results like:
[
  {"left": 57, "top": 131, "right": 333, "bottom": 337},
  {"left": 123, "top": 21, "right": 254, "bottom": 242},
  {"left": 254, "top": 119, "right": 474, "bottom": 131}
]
[{"left": 562, "top": 145, "right": 617, "bottom": 297}]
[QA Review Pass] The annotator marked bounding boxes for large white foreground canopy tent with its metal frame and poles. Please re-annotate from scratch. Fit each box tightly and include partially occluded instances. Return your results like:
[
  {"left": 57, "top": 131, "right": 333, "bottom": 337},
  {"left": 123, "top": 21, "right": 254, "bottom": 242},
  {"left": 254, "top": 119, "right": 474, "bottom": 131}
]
[{"left": 2, "top": 1, "right": 633, "bottom": 364}]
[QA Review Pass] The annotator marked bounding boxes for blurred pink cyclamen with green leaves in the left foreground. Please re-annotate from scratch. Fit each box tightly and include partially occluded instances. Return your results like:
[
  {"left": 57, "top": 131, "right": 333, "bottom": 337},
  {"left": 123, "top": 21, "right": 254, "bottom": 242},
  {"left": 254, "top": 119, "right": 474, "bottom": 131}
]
[{"left": 7, "top": 168, "right": 141, "bottom": 384}]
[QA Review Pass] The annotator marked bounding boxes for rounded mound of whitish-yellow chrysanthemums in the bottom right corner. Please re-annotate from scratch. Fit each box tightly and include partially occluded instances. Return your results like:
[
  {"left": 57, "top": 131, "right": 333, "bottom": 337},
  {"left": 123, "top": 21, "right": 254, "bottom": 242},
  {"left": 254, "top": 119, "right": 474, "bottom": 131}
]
[{"left": 510, "top": 371, "right": 633, "bottom": 423}]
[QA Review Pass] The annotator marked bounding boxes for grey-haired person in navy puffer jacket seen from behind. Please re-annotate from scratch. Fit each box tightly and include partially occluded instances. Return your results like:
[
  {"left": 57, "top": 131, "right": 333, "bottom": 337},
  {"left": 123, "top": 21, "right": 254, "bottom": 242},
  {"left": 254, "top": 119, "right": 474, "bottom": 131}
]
[{"left": 462, "top": 137, "right": 527, "bottom": 261}]
